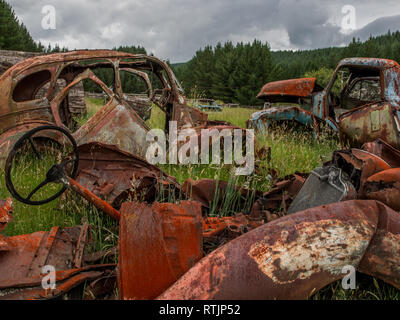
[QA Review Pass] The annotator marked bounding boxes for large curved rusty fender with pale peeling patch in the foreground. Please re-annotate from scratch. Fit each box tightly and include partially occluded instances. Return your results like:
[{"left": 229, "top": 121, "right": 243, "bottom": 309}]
[{"left": 158, "top": 200, "right": 400, "bottom": 300}]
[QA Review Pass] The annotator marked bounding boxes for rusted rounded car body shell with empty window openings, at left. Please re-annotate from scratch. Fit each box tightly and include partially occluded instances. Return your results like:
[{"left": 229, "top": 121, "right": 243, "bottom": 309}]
[{"left": 0, "top": 50, "right": 211, "bottom": 163}]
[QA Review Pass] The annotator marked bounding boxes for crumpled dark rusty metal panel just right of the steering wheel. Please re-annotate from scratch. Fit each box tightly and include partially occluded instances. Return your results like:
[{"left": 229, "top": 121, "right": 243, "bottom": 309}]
[{"left": 76, "top": 142, "right": 180, "bottom": 208}]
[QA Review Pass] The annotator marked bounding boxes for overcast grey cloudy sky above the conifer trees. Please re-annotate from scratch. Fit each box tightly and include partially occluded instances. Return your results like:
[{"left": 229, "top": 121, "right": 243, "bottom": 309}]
[{"left": 7, "top": 0, "right": 400, "bottom": 62}]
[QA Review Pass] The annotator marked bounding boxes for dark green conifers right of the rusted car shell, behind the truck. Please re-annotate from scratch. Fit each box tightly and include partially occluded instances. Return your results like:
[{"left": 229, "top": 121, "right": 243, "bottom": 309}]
[{"left": 174, "top": 31, "right": 400, "bottom": 105}]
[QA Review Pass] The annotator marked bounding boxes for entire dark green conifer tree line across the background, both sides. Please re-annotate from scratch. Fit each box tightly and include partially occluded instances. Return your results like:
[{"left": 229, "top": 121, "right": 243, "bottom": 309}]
[{"left": 0, "top": 0, "right": 400, "bottom": 105}]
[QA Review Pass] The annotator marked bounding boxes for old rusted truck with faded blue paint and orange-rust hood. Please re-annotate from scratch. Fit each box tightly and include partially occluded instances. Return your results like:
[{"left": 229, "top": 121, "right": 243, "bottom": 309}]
[{"left": 248, "top": 58, "right": 400, "bottom": 148}]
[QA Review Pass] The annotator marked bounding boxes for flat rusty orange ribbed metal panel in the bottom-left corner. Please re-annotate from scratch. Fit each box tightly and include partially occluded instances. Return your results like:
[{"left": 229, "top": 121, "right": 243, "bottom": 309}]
[{"left": 0, "top": 225, "right": 115, "bottom": 299}]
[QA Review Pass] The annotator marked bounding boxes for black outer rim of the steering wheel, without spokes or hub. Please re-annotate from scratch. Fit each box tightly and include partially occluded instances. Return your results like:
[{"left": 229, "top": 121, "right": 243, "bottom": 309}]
[{"left": 4, "top": 125, "right": 79, "bottom": 205}]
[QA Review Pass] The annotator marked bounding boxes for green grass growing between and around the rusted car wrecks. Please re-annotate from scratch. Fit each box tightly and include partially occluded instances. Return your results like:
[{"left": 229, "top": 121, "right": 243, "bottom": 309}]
[{"left": 0, "top": 99, "right": 400, "bottom": 299}]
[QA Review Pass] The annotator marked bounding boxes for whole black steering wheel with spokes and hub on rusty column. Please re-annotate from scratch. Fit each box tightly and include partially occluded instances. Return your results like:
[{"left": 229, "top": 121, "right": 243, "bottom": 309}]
[{"left": 5, "top": 125, "right": 79, "bottom": 205}]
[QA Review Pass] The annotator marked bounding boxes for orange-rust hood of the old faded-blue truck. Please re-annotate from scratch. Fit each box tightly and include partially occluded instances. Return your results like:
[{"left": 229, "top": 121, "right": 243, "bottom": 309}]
[{"left": 257, "top": 78, "right": 319, "bottom": 99}]
